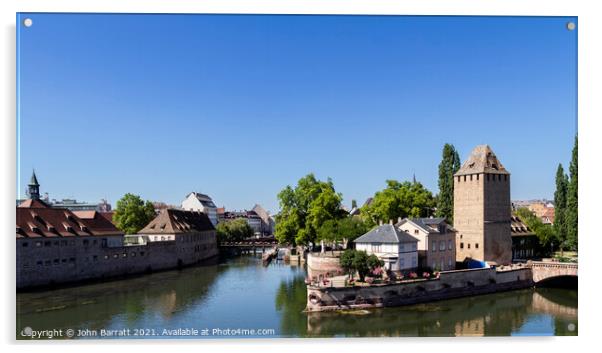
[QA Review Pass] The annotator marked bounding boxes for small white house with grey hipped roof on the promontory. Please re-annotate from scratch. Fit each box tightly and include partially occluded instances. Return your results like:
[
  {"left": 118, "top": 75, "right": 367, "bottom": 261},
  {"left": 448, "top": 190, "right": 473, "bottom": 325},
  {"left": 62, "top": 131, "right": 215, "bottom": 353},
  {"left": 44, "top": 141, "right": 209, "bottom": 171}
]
[{"left": 353, "top": 222, "right": 418, "bottom": 272}]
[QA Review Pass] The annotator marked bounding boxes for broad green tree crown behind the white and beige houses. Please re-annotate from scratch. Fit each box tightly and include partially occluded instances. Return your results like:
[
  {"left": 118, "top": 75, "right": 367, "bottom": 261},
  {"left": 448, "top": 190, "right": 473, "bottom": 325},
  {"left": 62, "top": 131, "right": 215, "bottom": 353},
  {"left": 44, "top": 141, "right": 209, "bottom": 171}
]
[{"left": 361, "top": 180, "right": 435, "bottom": 226}]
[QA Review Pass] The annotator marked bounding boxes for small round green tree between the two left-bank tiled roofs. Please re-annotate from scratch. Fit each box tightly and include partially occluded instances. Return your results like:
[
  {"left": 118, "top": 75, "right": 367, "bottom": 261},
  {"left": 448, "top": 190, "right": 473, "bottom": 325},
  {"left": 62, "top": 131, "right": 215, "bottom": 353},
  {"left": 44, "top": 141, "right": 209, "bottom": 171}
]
[{"left": 113, "top": 193, "right": 155, "bottom": 234}]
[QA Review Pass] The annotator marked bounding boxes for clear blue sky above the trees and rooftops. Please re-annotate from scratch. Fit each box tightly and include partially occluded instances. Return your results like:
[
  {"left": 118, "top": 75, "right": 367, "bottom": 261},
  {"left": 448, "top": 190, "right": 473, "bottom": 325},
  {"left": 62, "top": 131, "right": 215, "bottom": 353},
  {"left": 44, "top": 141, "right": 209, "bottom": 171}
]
[{"left": 17, "top": 14, "right": 577, "bottom": 211}]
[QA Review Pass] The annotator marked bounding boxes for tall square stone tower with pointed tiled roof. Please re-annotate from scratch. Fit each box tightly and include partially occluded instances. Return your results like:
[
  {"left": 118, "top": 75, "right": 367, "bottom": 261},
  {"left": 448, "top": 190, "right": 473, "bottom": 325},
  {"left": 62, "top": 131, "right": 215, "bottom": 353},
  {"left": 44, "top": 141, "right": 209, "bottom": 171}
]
[{"left": 454, "top": 145, "right": 512, "bottom": 265}]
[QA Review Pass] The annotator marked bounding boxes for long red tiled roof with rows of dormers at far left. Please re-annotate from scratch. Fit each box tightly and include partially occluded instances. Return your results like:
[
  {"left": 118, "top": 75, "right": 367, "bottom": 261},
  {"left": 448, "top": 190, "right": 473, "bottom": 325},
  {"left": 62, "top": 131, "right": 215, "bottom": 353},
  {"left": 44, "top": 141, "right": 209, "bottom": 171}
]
[{"left": 16, "top": 200, "right": 123, "bottom": 238}]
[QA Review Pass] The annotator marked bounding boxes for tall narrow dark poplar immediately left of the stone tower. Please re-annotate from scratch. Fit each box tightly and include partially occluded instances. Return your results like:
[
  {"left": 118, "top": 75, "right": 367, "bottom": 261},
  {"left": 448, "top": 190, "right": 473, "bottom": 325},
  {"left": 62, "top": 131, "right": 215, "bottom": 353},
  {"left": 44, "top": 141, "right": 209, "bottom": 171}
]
[{"left": 437, "top": 143, "right": 460, "bottom": 223}]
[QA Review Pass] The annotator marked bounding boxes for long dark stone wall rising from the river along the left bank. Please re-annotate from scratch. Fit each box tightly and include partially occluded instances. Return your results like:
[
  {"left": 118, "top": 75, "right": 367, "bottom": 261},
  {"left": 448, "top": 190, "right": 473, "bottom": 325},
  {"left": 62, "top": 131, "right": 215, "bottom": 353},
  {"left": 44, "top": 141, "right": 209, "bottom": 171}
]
[{"left": 16, "top": 230, "right": 218, "bottom": 290}]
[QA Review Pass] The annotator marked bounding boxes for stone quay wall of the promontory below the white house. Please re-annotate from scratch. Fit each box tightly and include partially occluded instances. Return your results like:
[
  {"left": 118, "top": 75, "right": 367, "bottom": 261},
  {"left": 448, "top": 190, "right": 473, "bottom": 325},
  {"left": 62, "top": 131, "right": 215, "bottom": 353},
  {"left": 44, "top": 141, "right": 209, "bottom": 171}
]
[{"left": 306, "top": 268, "right": 533, "bottom": 312}]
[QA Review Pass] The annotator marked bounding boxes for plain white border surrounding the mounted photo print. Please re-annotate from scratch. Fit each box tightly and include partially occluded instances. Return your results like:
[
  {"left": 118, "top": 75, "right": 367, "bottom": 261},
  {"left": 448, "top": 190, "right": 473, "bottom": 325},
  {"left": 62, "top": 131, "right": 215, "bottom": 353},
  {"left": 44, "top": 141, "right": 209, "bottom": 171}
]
[{"left": 0, "top": 0, "right": 602, "bottom": 353}]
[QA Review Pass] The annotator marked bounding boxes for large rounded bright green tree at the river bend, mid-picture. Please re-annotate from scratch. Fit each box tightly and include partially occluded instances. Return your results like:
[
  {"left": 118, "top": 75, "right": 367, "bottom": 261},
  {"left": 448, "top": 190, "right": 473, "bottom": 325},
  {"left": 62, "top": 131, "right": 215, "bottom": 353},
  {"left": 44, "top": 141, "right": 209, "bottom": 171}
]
[{"left": 275, "top": 174, "right": 347, "bottom": 246}]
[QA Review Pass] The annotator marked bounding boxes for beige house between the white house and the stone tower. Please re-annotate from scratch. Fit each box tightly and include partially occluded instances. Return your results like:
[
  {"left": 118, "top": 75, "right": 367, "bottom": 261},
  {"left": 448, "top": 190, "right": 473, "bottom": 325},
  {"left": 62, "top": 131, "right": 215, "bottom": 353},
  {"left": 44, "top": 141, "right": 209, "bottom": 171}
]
[{"left": 395, "top": 218, "right": 456, "bottom": 271}]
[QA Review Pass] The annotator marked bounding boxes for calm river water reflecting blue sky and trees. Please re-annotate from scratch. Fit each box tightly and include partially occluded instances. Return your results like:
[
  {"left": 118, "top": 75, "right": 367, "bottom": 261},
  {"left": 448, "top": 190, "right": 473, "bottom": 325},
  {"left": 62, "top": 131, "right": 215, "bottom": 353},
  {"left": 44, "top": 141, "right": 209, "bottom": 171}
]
[{"left": 17, "top": 256, "right": 578, "bottom": 339}]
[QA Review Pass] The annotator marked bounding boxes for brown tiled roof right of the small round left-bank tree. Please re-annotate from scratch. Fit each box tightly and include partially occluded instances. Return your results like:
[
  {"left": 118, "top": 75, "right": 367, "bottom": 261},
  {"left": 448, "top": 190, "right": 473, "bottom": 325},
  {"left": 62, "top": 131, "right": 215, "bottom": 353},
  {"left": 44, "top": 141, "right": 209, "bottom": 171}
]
[{"left": 138, "top": 209, "right": 215, "bottom": 234}]
